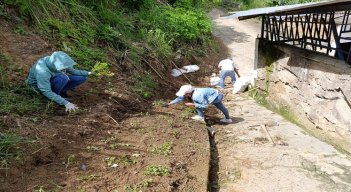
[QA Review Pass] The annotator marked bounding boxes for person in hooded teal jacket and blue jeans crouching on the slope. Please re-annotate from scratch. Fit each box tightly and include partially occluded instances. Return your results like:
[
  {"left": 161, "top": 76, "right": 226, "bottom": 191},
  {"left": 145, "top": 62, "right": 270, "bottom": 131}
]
[{"left": 26, "top": 51, "right": 91, "bottom": 112}]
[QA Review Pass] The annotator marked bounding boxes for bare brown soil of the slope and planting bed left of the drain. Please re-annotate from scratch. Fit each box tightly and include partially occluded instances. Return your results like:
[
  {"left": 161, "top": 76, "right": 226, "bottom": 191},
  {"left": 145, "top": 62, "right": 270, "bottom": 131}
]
[{"left": 0, "top": 14, "right": 227, "bottom": 191}]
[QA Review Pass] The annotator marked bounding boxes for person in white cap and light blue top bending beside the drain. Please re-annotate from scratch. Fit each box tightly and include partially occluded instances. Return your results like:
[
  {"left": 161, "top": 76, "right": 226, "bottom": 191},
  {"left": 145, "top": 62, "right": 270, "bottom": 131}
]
[{"left": 167, "top": 85, "right": 232, "bottom": 123}]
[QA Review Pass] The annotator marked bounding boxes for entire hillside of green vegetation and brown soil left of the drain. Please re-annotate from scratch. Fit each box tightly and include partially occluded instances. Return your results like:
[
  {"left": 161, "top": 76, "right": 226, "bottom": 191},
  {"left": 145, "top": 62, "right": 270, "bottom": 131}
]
[{"left": 0, "top": 0, "right": 226, "bottom": 191}]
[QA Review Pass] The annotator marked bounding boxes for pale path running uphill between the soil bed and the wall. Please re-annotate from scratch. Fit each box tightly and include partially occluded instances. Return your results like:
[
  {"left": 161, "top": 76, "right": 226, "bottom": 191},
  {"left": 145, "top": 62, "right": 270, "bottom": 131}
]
[{"left": 211, "top": 10, "right": 351, "bottom": 192}]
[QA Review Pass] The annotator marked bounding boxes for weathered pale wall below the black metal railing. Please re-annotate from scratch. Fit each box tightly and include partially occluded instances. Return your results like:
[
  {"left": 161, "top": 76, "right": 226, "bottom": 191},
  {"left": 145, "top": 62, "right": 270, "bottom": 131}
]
[{"left": 256, "top": 39, "right": 351, "bottom": 152}]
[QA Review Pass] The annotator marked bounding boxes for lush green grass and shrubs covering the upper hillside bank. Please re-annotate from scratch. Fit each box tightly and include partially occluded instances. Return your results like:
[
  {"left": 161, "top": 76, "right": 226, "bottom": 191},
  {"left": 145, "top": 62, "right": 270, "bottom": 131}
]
[{"left": 5, "top": 0, "right": 212, "bottom": 68}]
